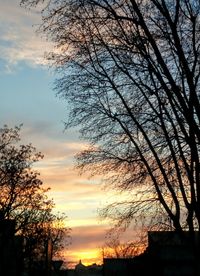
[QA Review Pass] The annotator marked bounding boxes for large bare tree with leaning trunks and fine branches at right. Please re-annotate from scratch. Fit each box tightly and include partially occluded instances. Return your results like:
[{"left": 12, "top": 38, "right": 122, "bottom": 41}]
[{"left": 22, "top": 0, "right": 200, "bottom": 244}]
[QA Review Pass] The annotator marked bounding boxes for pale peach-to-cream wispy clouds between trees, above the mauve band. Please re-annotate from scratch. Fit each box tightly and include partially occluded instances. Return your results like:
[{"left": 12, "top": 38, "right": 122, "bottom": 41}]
[{"left": 22, "top": 124, "right": 104, "bottom": 226}]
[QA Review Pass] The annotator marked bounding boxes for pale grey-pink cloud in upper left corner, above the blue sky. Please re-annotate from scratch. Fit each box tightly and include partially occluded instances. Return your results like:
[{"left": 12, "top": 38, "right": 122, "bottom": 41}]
[{"left": 0, "top": 0, "right": 52, "bottom": 70}]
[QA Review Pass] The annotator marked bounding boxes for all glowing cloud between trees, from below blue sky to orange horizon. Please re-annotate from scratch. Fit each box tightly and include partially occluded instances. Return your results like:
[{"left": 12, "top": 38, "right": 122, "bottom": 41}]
[{"left": 19, "top": 123, "right": 111, "bottom": 266}]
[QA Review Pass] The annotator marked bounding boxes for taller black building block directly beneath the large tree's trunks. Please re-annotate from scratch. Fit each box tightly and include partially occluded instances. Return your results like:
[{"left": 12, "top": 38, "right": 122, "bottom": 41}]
[{"left": 148, "top": 231, "right": 200, "bottom": 276}]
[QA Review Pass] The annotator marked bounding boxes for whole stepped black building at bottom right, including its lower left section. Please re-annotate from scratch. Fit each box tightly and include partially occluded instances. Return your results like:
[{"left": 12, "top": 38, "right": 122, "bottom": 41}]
[{"left": 103, "top": 231, "right": 200, "bottom": 276}]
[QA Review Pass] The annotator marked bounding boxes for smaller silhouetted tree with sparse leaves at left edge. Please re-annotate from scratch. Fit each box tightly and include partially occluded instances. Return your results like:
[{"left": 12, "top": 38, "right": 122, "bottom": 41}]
[{"left": 0, "top": 126, "right": 69, "bottom": 268}]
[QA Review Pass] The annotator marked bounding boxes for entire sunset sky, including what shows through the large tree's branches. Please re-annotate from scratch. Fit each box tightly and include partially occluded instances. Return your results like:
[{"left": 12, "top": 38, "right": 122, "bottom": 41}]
[{"left": 0, "top": 0, "right": 200, "bottom": 270}]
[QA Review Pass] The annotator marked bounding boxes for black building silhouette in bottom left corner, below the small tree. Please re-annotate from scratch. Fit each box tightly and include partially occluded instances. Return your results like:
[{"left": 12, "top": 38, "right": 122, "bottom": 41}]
[{"left": 0, "top": 218, "right": 67, "bottom": 276}]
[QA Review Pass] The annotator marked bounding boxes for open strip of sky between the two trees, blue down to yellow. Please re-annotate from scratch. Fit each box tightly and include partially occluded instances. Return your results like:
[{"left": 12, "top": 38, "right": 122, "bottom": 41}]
[{"left": 0, "top": 0, "right": 117, "bottom": 264}]
